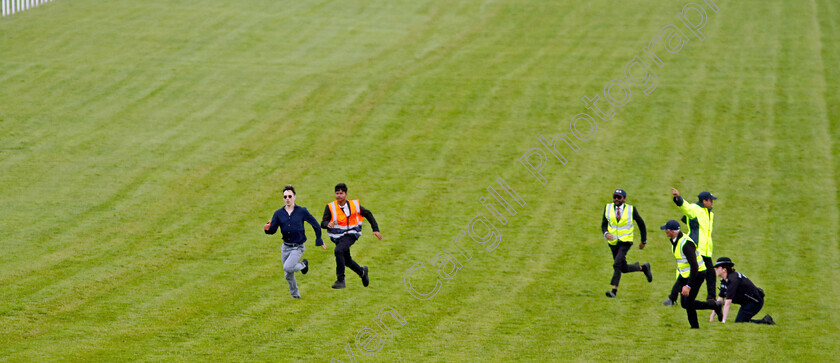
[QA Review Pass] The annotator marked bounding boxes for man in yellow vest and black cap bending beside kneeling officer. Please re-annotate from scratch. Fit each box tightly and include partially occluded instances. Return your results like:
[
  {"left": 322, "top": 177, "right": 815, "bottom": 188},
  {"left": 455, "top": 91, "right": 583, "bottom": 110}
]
[{"left": 659, "top": 220, "right": 722, "bottom": 329}]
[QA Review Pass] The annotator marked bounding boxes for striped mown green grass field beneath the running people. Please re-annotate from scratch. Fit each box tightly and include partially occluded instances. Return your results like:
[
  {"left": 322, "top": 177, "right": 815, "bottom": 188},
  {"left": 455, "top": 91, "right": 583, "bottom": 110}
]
[{"left": 0, "top": 0, "right": 840, "bottom": 362}]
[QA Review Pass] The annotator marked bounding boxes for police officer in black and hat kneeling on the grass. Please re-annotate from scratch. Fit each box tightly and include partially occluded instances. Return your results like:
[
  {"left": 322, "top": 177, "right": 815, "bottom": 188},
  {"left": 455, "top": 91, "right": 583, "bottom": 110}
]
[{"left": 709, "top": 257, "right": 776, "bottom": 325}]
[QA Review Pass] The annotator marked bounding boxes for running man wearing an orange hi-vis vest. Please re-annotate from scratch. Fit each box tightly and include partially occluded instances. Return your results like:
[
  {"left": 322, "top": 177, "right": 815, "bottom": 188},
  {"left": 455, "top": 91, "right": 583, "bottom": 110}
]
[{"left": 321, "top": 183, "right": 382, "bottom": 289}]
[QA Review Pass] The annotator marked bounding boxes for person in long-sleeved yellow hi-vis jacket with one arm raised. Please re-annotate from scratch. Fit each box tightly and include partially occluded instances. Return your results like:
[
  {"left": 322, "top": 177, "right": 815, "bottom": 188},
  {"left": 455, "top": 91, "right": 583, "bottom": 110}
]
[{"left": 664, "top": 188, "right": 717, "bottom": 305}]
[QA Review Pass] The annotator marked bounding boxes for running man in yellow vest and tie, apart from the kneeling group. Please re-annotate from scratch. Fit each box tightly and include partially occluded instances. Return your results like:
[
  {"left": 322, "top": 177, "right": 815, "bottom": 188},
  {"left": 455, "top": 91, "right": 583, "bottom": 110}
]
[{"left": 601, "top": 189, "right": 653, "bottom": 297}]
